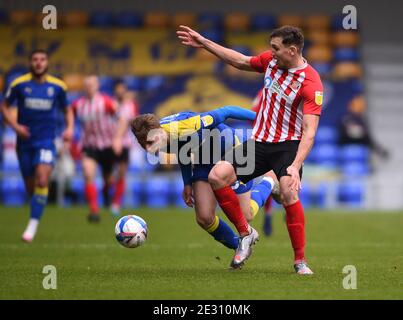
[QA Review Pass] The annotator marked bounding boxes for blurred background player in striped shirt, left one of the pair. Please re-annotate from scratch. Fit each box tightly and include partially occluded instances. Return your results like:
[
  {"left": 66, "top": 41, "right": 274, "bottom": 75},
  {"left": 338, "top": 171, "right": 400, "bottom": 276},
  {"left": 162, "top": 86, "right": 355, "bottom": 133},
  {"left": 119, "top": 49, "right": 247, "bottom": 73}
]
[{"left": 72, "top": 75, "right": 117, "bottom": 222}]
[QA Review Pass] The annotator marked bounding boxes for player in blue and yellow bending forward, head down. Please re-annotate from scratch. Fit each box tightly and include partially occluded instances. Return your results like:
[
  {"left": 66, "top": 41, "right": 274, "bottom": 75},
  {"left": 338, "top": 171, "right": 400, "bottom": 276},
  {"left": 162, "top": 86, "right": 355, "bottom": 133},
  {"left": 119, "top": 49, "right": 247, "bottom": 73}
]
[{"left": 132, "top": 107, "right": 275, "bottom": 266}]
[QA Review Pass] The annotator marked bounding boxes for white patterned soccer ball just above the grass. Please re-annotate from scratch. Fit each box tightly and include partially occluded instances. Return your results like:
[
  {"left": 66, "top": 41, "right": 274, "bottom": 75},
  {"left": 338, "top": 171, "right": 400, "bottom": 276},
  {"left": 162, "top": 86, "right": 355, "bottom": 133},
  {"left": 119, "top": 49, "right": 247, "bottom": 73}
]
[{"left": 115, "top": 215, "right": 147, "bottom": 248}]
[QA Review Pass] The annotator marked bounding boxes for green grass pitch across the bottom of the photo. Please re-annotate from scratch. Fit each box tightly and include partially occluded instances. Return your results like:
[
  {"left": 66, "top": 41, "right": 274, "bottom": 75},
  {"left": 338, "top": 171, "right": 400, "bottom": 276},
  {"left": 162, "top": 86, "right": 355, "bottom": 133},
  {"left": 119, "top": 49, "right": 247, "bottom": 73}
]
[{"left": 0, "top": 207, "right": 403, "bottom": 299}]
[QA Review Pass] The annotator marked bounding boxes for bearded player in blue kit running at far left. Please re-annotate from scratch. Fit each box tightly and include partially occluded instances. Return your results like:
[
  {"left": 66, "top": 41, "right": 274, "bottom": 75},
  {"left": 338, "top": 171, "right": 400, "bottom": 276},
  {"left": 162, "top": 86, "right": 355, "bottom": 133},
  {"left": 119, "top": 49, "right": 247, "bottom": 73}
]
[{"left": 2, "top": 50, "right": 73, "bottom": 242}]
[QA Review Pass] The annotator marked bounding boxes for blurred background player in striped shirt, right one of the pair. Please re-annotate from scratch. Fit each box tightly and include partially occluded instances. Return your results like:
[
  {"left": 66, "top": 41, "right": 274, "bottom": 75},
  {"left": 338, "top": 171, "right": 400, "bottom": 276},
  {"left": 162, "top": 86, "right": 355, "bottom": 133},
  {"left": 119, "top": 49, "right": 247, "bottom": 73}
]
[{"left": 111, "top": 81, "right": 139, "bottom": 216}]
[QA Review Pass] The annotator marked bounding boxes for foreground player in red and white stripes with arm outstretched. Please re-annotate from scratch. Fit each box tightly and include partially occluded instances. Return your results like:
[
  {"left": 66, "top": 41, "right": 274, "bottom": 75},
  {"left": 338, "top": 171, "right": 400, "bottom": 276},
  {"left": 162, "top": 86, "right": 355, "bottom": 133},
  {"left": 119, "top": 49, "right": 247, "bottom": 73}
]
[{"left": 177, "top": 26, "right": 323, "bottom": 274}]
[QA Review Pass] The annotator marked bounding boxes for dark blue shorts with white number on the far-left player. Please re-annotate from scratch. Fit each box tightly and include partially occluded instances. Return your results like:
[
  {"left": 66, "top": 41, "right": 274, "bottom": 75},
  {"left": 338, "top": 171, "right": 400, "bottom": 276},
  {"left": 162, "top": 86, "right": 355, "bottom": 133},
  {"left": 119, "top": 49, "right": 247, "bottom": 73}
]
[{"left": 17, "top": 142, "right": 56, "bottom": 178}]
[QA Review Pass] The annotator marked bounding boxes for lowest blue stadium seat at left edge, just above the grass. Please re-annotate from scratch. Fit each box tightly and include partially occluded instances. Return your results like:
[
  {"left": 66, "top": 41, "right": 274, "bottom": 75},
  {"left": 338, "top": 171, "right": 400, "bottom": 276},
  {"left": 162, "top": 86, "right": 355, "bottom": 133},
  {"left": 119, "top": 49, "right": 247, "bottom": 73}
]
[{"left": 0, "top": 177, "right": 27, "bottom": 206}]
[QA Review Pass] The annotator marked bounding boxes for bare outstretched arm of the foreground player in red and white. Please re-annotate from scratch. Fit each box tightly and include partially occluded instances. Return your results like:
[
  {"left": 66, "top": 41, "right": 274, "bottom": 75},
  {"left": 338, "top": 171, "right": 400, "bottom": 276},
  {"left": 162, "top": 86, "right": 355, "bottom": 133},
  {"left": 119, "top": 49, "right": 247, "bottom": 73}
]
[{"left": 176, "top": 26, "right": 256, "bottom": 71}]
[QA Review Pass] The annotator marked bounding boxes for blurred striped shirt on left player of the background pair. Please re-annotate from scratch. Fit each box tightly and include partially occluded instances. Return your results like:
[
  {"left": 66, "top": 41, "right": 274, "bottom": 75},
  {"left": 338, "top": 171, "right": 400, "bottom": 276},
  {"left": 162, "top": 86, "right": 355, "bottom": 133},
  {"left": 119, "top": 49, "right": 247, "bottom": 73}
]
[{"left": 72, "top": 93, "right": 116, "bottom": 150}]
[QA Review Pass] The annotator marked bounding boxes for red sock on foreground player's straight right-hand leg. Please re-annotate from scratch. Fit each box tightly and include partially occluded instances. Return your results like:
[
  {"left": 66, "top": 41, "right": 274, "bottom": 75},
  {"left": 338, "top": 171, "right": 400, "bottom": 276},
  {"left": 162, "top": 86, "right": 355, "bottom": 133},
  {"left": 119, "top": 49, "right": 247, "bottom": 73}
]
[{"left": 284, "top": 200, "right": 305, "bottom": 261}]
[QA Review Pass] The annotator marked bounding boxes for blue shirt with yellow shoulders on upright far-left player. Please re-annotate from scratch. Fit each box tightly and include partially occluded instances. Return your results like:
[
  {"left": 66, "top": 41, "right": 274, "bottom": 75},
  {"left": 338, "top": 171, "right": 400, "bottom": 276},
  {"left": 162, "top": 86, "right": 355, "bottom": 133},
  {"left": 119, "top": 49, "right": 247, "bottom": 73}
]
[{"left": 5, "top": 73, "right": 68, "bottom": 147}]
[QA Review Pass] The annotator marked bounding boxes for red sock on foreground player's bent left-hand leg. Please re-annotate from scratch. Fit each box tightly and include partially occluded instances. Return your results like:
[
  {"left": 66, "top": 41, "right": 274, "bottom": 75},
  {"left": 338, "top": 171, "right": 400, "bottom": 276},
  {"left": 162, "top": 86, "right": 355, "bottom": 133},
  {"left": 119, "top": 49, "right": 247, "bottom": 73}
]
[{"left": 214, "top": 186, "right": 249, "bottom": 236}]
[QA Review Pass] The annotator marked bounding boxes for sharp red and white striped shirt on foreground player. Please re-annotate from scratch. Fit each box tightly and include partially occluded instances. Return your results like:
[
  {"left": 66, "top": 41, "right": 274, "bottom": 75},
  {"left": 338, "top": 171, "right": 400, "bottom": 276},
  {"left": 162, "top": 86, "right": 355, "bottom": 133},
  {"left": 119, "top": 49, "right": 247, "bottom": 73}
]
[{"left": 250, "top": 51, "right": 323, "bottom": 143}]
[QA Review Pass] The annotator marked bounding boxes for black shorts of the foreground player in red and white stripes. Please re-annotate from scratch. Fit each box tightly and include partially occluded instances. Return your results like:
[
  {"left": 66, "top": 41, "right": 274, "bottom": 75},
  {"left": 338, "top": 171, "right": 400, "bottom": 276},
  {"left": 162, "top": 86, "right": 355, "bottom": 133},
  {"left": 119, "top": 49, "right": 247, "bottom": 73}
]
[{"left": 223, "top": 139, "right": 302, "bottom": 183}]
